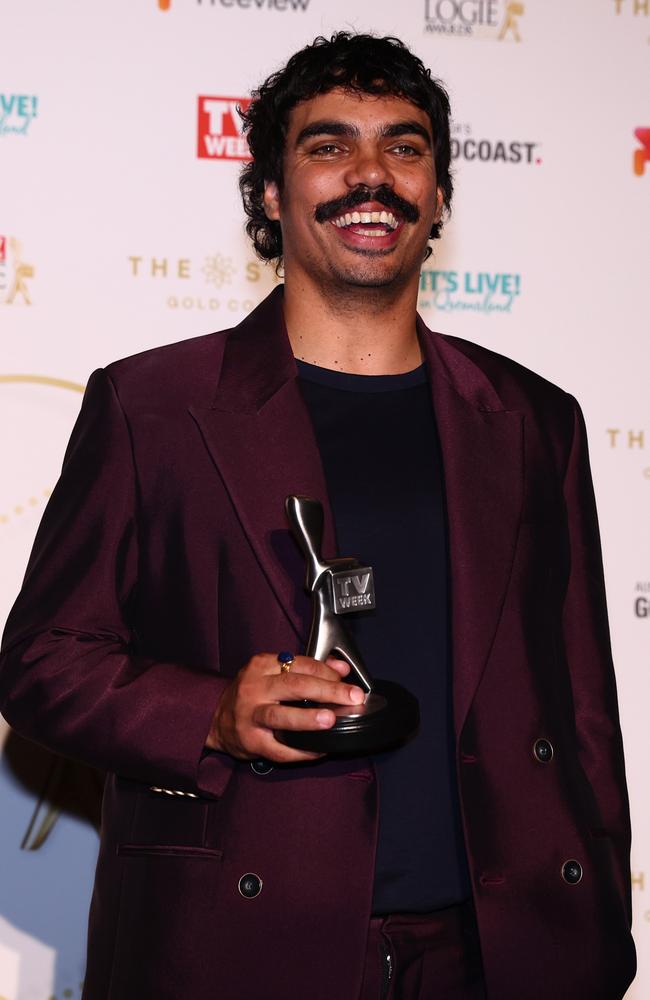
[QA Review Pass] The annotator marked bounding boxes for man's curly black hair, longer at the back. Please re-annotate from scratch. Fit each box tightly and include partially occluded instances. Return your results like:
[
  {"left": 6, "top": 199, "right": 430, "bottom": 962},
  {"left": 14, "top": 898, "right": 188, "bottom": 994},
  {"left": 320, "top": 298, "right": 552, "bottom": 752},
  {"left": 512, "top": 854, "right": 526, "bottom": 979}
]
[{"left": 239, "top": 31, "right": 453, "bottom": 262}]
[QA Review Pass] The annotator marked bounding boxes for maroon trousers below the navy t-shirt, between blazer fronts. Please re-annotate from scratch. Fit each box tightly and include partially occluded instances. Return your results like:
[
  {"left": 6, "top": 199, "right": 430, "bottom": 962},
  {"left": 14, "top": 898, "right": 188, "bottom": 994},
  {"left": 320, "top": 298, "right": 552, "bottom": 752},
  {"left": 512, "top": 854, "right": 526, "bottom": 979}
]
[{"left": 360, "top": 902, "right": 485, "bottom": 1000}]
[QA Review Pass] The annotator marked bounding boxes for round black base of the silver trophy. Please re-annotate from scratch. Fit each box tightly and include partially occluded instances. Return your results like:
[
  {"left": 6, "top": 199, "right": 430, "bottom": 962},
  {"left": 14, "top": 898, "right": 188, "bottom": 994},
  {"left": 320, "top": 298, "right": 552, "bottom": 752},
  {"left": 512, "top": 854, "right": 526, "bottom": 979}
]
[{"left": 274, "top": 681, "right": 420, "bottom": 754}]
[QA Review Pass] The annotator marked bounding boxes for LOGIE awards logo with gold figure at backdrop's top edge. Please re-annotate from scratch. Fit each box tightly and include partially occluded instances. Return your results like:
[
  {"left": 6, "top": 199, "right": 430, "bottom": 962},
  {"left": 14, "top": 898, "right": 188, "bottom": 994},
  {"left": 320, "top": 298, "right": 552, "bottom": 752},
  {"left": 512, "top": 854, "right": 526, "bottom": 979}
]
[{"left": 424, "top": 0, "right": 526, "bottom": 42}]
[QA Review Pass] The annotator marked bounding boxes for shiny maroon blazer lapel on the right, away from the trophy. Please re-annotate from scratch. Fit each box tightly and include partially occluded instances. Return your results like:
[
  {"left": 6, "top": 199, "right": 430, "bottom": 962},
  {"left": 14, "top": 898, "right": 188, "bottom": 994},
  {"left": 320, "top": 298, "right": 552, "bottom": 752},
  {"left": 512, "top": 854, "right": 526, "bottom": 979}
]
[{"left": 419, "top": 324, "right": 523, "bottom": 736}]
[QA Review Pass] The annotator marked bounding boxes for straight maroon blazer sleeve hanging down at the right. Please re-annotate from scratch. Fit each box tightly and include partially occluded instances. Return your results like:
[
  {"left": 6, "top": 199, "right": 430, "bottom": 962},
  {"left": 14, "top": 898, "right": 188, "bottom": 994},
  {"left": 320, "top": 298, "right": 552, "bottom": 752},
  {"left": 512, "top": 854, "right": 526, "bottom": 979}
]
[{"left": 563, "top": 400, "right": 632, "bottom": 922}]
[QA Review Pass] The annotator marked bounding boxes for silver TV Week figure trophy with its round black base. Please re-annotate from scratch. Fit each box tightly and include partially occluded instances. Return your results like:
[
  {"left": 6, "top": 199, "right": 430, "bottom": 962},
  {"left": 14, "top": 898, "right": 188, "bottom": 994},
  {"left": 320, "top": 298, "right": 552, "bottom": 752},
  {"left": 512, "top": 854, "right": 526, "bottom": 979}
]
[{"left": 275, "top": 495, "right": 420, "bottom": 754}]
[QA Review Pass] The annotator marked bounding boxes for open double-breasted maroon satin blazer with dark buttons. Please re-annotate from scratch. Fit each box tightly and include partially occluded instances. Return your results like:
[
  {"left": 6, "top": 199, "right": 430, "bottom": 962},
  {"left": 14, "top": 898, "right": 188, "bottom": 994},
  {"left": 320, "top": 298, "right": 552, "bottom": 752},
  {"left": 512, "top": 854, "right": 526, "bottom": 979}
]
[{"left": 1, "top": 290, "right": 634, "bottom": 1000}]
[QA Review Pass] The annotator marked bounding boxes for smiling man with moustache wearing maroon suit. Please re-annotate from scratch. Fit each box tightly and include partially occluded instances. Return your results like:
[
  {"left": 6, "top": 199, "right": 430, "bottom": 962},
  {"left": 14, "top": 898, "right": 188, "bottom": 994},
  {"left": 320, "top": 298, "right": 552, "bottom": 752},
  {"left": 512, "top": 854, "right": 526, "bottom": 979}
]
[{"left": 2, "top": 34, "right": 634, "bottom": 1000}]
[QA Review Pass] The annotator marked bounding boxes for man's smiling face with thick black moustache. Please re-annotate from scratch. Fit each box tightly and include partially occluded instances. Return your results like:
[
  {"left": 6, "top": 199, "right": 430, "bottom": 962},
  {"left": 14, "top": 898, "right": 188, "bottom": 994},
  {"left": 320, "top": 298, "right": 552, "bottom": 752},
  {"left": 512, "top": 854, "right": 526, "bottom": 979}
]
[{"left": 264, "top": 89, "right": 442, "bottom": 291}]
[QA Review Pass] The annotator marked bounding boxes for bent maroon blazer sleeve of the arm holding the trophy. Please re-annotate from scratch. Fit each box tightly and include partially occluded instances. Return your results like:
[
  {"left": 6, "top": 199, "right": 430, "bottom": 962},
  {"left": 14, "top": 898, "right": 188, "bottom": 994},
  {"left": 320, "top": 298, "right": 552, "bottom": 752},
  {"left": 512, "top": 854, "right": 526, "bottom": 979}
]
[{"left": 0, "top": 370, "right": 233, "bottom": 795}]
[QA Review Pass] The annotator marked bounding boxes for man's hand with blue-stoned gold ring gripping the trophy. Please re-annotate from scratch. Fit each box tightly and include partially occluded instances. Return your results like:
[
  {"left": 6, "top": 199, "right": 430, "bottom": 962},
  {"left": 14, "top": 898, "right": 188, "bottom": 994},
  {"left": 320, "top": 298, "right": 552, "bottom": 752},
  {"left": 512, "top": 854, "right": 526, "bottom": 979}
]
[{"left": 206, "top": 653, "right": 365, "bottom": 763}]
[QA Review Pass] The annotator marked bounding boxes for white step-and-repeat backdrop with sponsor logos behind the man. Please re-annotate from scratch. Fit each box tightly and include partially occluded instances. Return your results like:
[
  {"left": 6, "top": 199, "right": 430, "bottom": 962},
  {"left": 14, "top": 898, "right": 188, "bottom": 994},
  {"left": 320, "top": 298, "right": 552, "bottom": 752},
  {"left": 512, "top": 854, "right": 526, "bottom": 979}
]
[{"left": 0, "top": 0, "right": 650, "bottom": 1000}]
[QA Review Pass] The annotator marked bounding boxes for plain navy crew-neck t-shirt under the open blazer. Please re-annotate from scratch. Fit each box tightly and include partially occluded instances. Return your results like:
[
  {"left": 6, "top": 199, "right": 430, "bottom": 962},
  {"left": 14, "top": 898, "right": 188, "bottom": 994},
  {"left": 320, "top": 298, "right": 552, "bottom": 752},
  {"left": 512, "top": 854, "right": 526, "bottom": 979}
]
[{"left": 297, "top": 361, "right": 471, "bottom": 914}]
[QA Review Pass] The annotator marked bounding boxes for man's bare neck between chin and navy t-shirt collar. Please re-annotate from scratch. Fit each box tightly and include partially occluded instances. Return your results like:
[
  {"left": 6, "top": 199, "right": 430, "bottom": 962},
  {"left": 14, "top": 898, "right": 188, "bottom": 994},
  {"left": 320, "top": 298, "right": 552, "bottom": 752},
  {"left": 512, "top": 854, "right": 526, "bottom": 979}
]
[{"left": 284, "top": 272, "right": 422, "bottom": 375}]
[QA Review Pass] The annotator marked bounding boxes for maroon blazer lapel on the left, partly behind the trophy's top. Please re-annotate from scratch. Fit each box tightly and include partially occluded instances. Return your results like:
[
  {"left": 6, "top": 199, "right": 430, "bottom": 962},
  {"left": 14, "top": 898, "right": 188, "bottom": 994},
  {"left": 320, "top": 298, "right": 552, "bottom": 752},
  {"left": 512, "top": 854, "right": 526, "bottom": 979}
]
[{"left": 190, "top": 289, "right": 335, "bottom": 642}]
